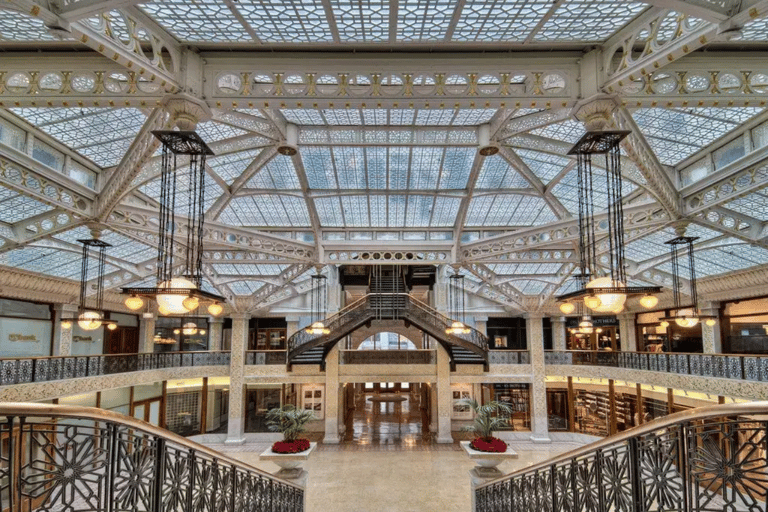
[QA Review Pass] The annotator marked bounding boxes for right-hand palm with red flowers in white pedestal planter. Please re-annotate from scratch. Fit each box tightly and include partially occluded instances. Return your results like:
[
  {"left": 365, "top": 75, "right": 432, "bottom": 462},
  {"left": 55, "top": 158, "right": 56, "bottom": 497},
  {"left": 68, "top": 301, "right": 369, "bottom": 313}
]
[{"left": 461, "top": 400, "right": 517, "bottom": 471}]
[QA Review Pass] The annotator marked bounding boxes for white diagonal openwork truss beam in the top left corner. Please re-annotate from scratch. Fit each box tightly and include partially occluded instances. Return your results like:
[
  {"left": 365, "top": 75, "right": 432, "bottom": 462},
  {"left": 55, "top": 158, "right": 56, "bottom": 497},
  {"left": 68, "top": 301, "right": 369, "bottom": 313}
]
[{"left": 0, "top": 0, "right": 182, "bottom": 93}]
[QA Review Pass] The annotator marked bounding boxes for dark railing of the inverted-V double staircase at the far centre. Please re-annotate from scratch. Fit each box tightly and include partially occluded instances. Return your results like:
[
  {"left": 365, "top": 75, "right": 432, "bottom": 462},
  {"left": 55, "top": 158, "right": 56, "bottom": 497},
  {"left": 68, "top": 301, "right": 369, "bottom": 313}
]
[{"left": 288, "top": 293, "right": 488, "bottom": 360}]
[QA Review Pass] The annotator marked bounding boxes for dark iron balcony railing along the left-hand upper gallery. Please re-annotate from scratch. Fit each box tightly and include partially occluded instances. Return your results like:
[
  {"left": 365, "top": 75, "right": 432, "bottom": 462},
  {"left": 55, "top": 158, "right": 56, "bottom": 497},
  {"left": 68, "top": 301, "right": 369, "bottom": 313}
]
[{"left": 0, "top": 351, "right": 230, "bottom": 386}]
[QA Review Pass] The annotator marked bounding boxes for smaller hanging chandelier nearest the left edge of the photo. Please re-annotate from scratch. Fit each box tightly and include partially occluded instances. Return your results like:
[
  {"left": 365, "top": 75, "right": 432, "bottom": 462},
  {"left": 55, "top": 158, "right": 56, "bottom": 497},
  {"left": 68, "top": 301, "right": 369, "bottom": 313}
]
[{"left": 61, "top": 238, "right": 117, "bottom": 331}]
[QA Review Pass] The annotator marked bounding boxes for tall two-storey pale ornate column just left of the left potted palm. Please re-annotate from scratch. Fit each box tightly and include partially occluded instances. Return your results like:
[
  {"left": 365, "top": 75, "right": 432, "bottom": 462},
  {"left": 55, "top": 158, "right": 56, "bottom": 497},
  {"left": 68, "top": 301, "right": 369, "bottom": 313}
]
[{"left": 224, "top": 313, "right": 251, "bottom": 444}]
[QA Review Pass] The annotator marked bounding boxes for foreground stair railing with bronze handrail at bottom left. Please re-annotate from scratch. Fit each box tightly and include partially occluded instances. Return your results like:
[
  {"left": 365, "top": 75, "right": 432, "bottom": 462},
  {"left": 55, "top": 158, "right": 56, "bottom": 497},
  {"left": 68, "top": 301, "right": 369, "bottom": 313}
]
[{"left": 0, "top": 403, "right": 304, "bottom": 512}]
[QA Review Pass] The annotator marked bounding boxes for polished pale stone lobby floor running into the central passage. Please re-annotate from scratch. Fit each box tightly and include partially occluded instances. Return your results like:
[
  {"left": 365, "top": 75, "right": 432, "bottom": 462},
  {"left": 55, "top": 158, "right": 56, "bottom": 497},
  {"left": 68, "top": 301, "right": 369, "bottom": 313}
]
[{"left": 212, "top": 397, "right": 578, "bottom": 512}]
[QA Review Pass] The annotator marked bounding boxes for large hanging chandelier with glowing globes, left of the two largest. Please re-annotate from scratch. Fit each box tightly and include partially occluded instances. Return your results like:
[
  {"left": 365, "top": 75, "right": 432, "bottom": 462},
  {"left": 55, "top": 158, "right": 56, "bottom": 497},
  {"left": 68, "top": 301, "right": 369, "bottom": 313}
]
[{"left": 123, "top": 131, "right": 224, "bottom": 316}]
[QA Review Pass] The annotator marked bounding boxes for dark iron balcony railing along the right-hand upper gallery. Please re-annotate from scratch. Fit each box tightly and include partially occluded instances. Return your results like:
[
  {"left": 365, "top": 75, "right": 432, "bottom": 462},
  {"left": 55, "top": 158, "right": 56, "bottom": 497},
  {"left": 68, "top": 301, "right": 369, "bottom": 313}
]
[{"left": 544, "top": 350, "right": 768, "bottom": 382}]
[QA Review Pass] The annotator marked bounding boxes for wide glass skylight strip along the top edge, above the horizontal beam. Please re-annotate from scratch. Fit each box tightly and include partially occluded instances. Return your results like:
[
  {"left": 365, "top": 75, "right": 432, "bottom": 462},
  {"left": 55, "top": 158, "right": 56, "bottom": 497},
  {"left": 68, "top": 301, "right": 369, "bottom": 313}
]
[{"left": 127, "top": 0, "right": 648, "bottom": 44}]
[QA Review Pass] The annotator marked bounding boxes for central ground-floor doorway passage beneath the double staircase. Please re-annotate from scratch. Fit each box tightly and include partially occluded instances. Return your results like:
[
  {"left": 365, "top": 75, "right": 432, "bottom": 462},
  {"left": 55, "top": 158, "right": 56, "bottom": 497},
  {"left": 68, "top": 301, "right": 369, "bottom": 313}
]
[{"left": 344, "top": 382, "right": 432, "bottom": 447}]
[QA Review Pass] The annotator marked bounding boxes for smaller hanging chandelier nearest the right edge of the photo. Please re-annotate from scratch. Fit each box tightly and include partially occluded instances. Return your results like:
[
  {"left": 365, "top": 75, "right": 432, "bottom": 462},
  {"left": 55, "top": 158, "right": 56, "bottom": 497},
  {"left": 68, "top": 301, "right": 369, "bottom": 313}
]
[{"left": 661, "top": 236, "right": 715, "bottom": 328}]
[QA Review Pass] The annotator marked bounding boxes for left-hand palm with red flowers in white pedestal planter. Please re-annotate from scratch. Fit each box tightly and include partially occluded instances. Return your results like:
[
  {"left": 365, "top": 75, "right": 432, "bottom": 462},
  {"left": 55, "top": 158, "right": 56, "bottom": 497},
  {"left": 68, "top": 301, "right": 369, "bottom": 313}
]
[{"left": 259, "top": 404, "right": 317, "bottom": 477}]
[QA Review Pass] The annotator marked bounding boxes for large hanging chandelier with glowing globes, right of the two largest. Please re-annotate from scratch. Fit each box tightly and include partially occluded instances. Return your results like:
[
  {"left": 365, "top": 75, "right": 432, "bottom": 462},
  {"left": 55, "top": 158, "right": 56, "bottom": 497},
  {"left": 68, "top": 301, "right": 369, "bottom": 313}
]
[{"left": 557, "top": 131, "right": 661, "bottom": 318}]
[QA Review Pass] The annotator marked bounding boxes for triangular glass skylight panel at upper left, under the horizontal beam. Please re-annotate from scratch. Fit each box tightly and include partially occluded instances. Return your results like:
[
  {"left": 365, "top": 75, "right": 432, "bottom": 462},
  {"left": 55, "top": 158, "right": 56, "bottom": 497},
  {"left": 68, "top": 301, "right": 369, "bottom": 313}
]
[{"left": 11, "top": 108, "right": 146, "bottom": 167}]
